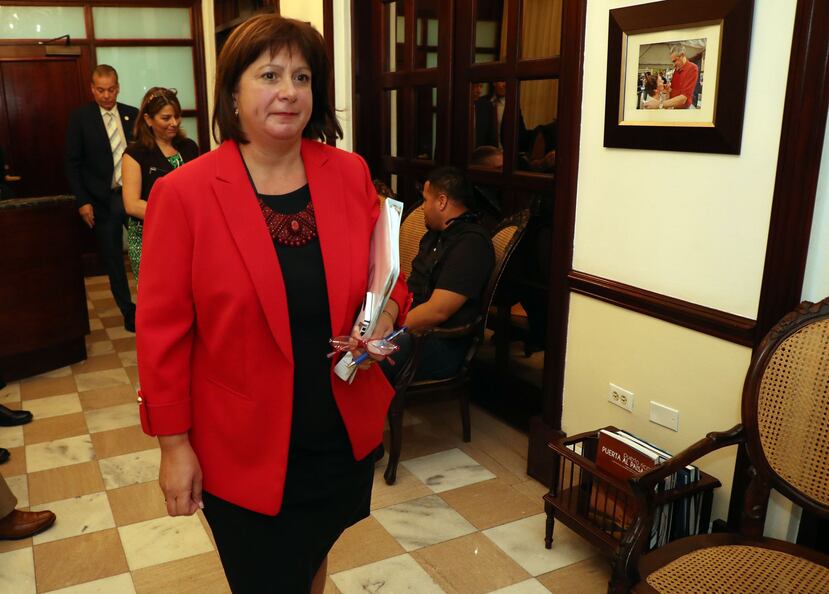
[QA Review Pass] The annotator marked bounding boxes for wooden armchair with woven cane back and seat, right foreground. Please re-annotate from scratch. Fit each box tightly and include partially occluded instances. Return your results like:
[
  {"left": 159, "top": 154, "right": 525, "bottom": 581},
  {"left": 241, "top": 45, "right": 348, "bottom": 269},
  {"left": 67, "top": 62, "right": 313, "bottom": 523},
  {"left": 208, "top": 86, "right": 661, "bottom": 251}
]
[{"left": 610, "top": 298, "right": 829, "bottom": 594}]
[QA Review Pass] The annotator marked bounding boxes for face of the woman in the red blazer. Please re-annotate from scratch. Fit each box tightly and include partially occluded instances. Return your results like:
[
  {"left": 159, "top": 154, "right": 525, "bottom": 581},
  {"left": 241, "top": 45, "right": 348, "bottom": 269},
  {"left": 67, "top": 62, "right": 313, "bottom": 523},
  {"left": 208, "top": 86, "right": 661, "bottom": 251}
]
[{"left": 233, "top": 48, "right": 314, "bottom": 144}]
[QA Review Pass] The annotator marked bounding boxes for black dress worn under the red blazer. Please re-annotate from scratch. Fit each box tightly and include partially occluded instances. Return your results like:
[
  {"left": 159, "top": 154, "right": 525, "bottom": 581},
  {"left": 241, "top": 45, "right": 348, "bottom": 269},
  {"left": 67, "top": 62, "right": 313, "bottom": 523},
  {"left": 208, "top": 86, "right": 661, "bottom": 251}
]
[{"left": 205, "top": 185, "right": 374, "bottom": 594}]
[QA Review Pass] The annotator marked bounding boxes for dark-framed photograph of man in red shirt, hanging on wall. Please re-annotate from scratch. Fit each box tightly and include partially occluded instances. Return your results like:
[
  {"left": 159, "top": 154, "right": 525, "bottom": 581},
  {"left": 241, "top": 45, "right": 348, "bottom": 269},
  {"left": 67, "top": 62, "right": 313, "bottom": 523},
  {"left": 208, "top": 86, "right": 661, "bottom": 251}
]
[{"left": 604, "top": 0, "right": 754, "bottom": 154}]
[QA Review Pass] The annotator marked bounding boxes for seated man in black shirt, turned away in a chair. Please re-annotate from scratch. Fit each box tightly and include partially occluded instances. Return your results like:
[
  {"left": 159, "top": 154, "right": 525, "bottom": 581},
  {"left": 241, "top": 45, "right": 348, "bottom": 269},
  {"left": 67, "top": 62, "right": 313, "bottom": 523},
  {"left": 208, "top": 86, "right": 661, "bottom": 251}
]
[{"left": 382, "top": 167, "right": 495, "bottom": 383}]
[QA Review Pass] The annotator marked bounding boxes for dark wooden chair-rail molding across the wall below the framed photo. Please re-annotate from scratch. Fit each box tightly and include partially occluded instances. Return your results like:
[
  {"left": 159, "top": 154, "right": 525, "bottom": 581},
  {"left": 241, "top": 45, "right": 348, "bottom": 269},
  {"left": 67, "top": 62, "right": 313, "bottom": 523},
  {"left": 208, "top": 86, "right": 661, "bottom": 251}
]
[{"left": 568, "top": 270, "right": 756, "bottom": 347}]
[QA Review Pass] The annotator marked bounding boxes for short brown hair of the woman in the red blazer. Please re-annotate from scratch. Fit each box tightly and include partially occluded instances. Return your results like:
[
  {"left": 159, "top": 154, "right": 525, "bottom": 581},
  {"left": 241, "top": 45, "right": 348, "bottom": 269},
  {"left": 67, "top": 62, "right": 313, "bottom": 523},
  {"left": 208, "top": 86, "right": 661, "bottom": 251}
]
[{"left": 213, "top": 14, "right": 343, "bottom": 144}]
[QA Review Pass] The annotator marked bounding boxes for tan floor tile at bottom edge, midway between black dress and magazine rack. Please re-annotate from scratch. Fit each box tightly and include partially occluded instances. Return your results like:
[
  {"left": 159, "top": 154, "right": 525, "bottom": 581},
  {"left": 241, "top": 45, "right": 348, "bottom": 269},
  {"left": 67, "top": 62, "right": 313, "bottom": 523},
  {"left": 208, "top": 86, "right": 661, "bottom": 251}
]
[{"left": 411, "top": 533, "right": 530, "bottom": 594}]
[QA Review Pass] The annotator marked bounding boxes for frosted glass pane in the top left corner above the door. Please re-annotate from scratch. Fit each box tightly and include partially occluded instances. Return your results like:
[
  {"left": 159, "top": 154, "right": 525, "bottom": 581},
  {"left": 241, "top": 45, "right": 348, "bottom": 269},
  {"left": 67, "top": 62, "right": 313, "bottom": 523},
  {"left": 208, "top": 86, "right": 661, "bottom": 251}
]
[{"left": 0, "top": 6, "right": 86, "bottom": 39}]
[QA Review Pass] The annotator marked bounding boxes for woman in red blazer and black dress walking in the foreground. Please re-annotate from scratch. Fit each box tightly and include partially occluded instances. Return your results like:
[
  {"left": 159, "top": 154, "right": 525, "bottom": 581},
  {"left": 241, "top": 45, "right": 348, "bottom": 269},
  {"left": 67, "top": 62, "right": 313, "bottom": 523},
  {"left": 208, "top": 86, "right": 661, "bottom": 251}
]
[{"left": 137, "top": 15, "right": 408, "bottom": 593}]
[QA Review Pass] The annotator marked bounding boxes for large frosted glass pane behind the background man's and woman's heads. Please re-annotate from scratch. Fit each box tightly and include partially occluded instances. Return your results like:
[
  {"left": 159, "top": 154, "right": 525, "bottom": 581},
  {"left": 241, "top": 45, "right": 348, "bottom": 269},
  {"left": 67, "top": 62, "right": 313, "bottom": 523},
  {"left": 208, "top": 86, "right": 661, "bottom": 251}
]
[{"left": 98, "top": 47, "right": 196, "bottom": 109}]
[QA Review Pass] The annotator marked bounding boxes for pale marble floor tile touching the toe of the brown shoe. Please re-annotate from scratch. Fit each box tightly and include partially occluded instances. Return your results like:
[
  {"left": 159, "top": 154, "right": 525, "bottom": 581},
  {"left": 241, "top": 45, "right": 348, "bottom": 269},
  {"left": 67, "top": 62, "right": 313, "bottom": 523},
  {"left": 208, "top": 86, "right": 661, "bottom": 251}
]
[{"left": 31, "top": 491, "right": 115, "bottom": 546}]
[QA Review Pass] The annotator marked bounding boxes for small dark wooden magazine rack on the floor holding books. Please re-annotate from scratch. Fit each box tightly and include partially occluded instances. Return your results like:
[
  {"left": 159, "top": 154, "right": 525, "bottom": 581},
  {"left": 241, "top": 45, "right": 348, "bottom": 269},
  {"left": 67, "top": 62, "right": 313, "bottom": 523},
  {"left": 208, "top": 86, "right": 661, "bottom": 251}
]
[{"left": 544, "top": 427, "right": 720, "bottom": 592}]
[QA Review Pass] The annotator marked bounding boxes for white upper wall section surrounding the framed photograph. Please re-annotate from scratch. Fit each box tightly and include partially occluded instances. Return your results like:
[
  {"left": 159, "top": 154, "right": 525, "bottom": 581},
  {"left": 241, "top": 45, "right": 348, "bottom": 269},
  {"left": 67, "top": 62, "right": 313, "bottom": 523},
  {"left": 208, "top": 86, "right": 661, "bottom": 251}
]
[{"left": 573, "top": 0, "right": 795, "bottom": 318}]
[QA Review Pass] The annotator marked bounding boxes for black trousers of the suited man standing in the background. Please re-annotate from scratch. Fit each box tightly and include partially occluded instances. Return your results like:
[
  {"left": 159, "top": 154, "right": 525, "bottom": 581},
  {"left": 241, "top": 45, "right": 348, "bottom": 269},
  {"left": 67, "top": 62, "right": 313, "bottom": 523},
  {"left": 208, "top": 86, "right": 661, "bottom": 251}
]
[{"left": 92, "top": 189, "right": 135, "bottom": 325}]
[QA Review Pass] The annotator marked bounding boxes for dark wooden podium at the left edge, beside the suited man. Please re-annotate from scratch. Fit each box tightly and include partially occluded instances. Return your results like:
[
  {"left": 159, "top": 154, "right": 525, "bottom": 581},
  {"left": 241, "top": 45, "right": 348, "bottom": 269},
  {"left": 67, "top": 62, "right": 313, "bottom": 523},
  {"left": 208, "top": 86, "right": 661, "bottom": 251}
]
[{"left": 0, "top": 196, "right": 89, "bottom": 380}]
